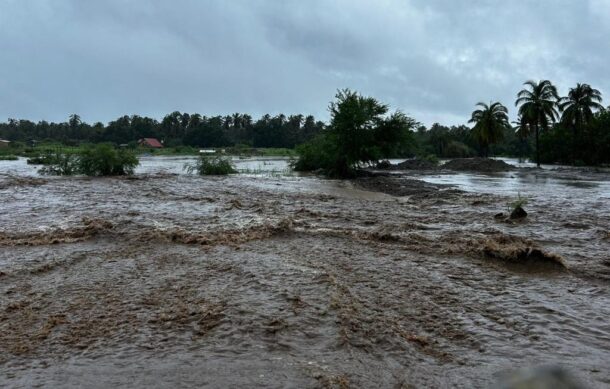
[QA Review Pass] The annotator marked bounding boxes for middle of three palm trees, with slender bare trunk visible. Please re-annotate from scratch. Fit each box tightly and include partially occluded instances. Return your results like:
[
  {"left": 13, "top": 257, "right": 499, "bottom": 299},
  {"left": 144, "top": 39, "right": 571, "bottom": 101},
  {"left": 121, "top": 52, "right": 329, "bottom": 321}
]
[{"left": 515, "top": 80, "right": 559, "bottom": 167}]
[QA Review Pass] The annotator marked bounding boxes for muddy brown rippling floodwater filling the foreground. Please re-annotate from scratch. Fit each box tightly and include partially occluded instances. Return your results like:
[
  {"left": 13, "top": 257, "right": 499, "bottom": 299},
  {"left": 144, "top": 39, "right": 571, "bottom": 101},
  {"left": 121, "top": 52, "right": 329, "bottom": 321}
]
[{"left": 0, "top": 157, "right": 610, "bottom": 388}]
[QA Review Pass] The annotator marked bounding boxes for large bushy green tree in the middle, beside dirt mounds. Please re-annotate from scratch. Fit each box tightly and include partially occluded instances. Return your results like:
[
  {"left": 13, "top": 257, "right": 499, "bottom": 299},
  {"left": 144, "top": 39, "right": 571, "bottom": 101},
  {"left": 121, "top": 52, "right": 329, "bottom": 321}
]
[{"left": 294, "top": 89, "right": 416, "bottom": 177}]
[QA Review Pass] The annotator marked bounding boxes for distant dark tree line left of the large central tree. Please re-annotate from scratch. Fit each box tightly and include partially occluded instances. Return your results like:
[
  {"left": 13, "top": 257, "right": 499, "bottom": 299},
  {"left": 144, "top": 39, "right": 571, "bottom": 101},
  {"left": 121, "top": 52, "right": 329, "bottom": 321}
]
[{"left": 0, "top": 112, "right": 325, "bottom": 148}]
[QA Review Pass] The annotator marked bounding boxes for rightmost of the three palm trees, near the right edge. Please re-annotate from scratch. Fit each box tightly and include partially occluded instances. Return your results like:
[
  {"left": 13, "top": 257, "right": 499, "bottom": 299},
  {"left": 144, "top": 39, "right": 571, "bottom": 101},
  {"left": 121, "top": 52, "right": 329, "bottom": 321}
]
[{"left": 558, "top": 83, "right": 604, "bottom": 163}]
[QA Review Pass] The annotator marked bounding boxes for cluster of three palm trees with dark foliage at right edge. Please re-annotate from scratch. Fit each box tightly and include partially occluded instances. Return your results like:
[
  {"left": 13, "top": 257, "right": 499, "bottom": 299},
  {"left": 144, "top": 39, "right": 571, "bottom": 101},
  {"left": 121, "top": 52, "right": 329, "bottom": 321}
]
[{"left": 469, "top": 80, "right": 610, "bottom": 166}]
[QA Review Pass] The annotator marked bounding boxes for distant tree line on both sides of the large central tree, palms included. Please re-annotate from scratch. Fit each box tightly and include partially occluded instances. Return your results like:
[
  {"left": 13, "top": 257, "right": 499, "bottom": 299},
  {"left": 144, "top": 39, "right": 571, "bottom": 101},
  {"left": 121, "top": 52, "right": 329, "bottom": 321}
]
[{"left": 0, "top": 80, "right": 610, "bottom": 165}]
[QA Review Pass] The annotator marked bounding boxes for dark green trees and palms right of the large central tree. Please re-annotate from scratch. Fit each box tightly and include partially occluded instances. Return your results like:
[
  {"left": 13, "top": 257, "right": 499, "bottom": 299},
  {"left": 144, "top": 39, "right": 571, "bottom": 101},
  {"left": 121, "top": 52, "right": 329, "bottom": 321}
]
[{"left": 415, "top": 80, "right": 610, "bottom": 165}]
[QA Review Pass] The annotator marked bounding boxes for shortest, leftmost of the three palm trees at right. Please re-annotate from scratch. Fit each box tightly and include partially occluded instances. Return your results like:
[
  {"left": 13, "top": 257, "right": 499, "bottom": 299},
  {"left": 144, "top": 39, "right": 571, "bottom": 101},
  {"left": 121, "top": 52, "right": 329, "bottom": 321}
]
[{"left": 468, "top": 102, "right": 510, "bottom": 157}]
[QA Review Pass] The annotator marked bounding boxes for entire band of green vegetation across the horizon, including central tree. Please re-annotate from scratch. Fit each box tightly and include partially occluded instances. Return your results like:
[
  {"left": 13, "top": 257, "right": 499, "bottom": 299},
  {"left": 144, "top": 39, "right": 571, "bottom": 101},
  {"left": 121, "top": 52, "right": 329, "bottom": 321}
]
[{"left": 0, "top": 80, "right": 610, "bottom": 167}]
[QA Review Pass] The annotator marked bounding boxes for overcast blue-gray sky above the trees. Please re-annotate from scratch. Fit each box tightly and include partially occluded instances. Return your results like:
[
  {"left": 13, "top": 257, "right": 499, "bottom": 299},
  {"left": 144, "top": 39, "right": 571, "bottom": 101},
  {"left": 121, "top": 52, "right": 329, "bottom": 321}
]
[{"left": 0, "top": 0, "right": 610, "bottom": 125}]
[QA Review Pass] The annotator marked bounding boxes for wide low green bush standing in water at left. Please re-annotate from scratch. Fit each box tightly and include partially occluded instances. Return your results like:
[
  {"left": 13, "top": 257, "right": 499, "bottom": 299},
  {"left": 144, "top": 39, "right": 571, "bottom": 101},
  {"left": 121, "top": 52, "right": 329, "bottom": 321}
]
[{"left": 39, "top": 143, "right": 139, "bottom": 176}]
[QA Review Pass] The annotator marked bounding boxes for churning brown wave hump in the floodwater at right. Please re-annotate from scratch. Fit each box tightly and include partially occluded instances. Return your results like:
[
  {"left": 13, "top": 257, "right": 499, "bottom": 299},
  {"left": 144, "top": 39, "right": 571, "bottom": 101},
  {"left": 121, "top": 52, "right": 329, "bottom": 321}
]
[{"left": 480, "top": 234, "right": 567, "bottom": 268}]
